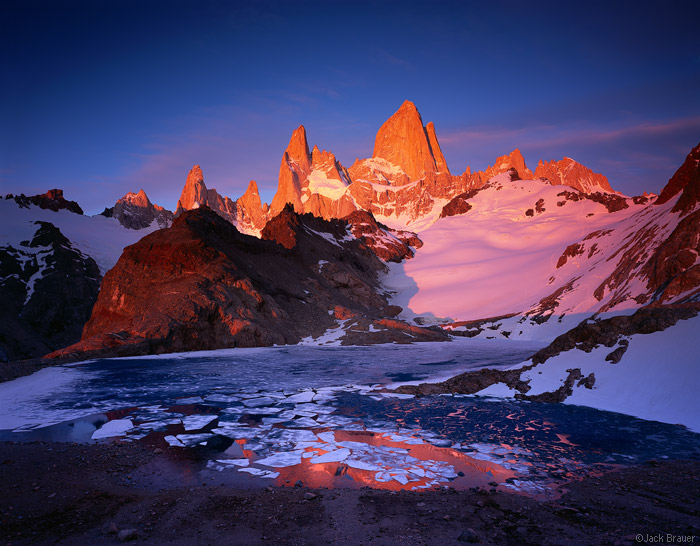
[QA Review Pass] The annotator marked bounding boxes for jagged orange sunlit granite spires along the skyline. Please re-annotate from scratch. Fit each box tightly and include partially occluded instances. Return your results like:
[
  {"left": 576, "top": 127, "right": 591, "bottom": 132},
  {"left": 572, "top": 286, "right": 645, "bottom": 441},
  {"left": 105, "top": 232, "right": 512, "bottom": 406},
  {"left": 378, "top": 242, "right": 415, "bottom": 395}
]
[{"left": 176, "top": 101, "right": 612, "bottom": 235}]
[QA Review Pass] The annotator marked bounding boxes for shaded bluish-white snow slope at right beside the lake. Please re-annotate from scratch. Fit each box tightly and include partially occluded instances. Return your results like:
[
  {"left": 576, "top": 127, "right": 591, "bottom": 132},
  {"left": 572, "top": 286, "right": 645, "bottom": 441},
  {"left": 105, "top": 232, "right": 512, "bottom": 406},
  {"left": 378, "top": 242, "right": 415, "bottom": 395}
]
[{"left": 478, "top": 310, "right": 700, "bottom": 432}]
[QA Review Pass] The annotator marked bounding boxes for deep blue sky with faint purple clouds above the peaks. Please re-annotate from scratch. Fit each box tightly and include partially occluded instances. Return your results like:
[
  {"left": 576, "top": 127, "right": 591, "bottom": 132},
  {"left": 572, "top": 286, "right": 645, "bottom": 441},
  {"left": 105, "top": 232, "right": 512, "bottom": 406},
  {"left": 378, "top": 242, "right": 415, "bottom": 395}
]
[{"left": 0, "top": 0, "right": 700, "bottom": 213}]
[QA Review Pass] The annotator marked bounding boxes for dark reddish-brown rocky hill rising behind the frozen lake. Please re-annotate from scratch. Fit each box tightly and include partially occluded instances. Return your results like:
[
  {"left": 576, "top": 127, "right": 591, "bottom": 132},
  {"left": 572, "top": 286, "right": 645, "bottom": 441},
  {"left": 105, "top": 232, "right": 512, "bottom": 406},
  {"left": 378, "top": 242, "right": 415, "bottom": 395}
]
[{"left": 51, "top": 206, "right": 446, "bottom": 358}]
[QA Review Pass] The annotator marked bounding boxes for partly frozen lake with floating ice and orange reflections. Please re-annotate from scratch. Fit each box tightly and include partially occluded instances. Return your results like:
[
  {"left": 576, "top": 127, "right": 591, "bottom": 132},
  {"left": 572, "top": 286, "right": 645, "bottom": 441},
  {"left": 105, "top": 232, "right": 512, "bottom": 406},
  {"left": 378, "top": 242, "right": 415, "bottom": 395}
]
[{"left": 0, "top": 339, "right": 700, "bottom": 496}]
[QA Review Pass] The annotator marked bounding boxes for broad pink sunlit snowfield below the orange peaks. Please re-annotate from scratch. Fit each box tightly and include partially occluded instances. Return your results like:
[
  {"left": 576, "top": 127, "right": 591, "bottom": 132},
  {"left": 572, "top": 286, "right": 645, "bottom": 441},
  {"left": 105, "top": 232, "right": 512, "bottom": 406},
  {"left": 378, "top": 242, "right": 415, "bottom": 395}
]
[{"left": 385, "top": 174, "right": 644, "bottom": 330}]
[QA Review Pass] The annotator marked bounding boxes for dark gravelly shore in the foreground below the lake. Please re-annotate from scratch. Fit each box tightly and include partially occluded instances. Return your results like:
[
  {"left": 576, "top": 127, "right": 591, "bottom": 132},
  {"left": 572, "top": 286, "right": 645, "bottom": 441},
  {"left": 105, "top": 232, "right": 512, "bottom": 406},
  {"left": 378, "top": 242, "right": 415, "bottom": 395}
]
[{"left": 0, "top": 443, "right": 700, "bottom": 546}]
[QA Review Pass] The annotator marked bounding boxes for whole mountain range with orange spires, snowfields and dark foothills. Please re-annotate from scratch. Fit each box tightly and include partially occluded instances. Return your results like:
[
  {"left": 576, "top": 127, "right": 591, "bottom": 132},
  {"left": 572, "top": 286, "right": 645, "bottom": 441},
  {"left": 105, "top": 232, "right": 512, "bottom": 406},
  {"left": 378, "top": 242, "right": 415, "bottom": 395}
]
[{"left": 0, "top": 101, "right": 700, "bottom": 424}]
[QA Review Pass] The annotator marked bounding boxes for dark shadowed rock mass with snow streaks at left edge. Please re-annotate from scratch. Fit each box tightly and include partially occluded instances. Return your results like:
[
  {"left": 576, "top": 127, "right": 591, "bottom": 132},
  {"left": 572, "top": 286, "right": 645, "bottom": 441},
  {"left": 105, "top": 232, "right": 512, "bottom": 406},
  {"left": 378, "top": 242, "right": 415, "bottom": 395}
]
[{"left": 0, "top": 222, "right": 101, "bottom": 361}]
